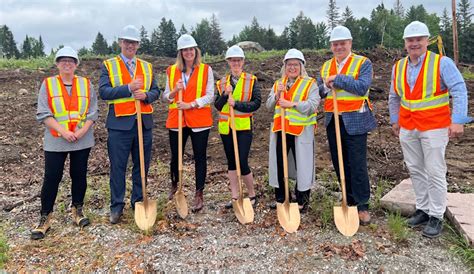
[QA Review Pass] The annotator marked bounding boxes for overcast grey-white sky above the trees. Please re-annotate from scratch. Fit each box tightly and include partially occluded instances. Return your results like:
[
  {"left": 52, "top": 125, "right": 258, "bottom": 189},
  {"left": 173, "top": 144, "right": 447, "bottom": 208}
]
[{"left": 0, "top": 0, "right": 451, "bottom": 53}]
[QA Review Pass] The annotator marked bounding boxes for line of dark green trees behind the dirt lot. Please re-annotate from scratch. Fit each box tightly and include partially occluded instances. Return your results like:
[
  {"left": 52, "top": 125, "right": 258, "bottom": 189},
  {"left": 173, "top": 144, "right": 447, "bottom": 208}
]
[{"left": 0, "top": 0, "right": 474, "bottom": 62}]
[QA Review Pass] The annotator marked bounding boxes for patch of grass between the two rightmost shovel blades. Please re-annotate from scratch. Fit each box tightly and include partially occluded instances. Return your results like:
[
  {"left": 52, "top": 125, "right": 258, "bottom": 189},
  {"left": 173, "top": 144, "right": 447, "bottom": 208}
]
[{"left": 310, "top": 192, "right": 334, "bottom": 229}]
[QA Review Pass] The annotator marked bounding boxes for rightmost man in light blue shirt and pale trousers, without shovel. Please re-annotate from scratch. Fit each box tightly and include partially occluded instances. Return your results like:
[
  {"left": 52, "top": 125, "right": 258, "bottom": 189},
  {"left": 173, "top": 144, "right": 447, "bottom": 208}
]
[{"left": 389, "top": 21, "right": 469, "bottom": 238}]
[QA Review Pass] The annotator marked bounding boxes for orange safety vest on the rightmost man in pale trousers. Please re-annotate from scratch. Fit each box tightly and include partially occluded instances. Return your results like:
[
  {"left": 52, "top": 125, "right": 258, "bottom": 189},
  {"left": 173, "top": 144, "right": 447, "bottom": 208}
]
[{"left": 392, "top": 51, "right": 451, "bottom": 131}]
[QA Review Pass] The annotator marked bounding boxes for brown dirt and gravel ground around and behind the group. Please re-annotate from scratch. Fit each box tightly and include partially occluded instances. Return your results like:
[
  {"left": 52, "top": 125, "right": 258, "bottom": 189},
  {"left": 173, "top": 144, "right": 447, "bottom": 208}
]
[{"left": 0, "top": 49, "right": 474, "bottom": 271}]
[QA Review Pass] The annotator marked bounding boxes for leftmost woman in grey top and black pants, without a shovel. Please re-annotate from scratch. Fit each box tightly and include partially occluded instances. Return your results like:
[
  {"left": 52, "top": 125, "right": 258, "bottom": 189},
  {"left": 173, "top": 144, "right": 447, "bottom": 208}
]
[{"left": 31, "top": 47, "right": 98, "bottom": 240}]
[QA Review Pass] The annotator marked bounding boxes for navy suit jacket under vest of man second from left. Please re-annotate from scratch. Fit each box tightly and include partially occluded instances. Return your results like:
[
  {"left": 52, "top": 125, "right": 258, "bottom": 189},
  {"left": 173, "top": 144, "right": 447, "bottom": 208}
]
[{"left": 99, "top": 62, "right": 160, "bottom": 130}]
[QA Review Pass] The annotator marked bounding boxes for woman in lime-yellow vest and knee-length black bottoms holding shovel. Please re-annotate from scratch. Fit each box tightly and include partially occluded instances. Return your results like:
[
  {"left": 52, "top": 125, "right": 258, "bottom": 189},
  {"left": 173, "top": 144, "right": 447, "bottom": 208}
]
[{"left": 214, "top": 45, "right": 261, "bottom": 208}]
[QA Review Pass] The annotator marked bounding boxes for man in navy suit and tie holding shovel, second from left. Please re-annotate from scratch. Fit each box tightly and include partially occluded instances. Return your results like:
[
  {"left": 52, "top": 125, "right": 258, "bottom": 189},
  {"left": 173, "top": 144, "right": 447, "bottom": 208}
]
[{"left": 99, "top": 25, "right": 160, "bottom": 224}]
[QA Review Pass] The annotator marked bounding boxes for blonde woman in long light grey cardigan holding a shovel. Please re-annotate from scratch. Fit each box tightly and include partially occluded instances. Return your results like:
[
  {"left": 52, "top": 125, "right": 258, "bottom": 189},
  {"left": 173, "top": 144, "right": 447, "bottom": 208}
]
[{"left": 266, "top": 49, "right": 321, "bottom": 212}]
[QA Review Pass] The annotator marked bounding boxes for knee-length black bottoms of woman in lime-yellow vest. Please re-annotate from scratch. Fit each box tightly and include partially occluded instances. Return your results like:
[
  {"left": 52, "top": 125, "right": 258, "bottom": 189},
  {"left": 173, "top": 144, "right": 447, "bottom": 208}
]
[{"left": 221, "top": 130, "right": 253, "bottom": 175}]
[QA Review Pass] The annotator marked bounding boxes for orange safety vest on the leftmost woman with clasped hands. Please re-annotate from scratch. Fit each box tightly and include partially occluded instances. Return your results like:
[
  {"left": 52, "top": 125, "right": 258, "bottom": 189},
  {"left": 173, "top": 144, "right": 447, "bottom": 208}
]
[{"left": 43, "top": 75, "right": 90, "bottom": 137}]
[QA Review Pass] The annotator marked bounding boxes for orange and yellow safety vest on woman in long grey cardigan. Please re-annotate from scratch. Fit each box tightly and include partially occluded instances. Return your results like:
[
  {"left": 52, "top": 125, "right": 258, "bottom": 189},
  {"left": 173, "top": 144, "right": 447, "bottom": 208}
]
[{"left": 272, "top": 76, "right": 317, "bottom": 136}]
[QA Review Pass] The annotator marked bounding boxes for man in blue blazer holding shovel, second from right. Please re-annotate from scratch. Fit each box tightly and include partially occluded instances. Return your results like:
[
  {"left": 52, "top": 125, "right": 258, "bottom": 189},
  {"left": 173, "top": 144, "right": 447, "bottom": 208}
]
[{"left": 318, "top": 26, "right": 377, "bottom": 225}]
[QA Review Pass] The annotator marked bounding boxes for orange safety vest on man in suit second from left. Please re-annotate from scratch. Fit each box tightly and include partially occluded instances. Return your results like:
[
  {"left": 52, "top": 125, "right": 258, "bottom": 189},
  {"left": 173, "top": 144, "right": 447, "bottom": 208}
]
[{"left": 104, "top": 56, "right": 153, "bottom": 117}]
